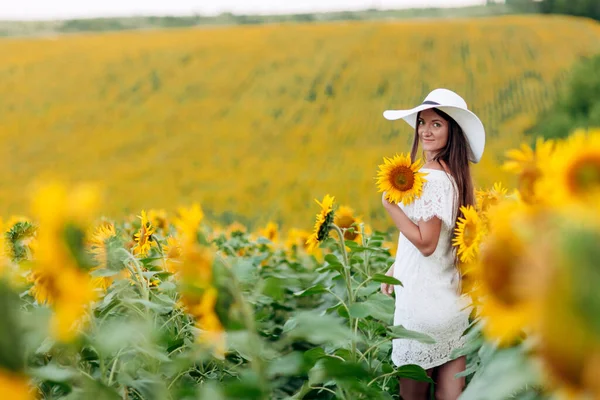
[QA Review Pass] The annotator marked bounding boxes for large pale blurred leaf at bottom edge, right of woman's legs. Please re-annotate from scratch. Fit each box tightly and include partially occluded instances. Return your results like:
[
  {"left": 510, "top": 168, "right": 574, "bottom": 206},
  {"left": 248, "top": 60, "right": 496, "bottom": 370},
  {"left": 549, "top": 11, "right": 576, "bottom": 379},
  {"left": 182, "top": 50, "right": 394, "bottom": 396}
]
[{"left": 461, "top": 347, "right": 541, "bottom": 400}]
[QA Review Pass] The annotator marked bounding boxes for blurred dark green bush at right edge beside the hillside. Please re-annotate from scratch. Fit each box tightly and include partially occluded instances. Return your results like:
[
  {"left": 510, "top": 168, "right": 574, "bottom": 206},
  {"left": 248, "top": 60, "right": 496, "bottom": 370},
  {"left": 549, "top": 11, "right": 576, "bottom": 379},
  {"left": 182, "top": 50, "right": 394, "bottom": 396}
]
[{"left": 529, "top": 54, "right": 600, "bottom": 138}]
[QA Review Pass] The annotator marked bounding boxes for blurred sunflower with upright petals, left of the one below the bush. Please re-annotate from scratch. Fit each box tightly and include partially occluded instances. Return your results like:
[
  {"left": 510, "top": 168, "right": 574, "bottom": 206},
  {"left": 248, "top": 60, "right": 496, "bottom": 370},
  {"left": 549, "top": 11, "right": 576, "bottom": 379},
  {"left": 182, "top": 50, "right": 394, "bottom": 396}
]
[{"left": 503, "top": 138, "right": 555, "bottom": 204}]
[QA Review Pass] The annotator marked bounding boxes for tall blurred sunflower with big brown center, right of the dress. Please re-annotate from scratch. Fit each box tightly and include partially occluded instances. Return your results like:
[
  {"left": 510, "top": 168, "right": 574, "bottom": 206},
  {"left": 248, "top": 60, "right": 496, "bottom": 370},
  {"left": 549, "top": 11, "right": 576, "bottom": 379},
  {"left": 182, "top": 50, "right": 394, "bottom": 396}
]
[{"left": 473, "top": 201, "right": 536, "bottom": 344}]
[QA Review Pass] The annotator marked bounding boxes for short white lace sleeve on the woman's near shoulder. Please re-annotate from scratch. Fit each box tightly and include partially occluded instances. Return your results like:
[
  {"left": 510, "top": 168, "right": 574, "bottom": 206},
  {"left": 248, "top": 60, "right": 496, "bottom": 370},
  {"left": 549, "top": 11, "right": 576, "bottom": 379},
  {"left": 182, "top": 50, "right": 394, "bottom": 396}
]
[{"left": 406, "top": 176, "right": 457, "bottom": 228}]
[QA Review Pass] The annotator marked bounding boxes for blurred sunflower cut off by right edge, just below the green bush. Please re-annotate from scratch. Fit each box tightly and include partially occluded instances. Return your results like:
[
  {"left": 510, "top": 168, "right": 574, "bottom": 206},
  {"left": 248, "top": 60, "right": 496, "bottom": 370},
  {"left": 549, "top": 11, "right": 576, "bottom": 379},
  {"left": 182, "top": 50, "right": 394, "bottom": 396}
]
[{"left": 539, "top": 129, "right": 600, "bottom": 210}]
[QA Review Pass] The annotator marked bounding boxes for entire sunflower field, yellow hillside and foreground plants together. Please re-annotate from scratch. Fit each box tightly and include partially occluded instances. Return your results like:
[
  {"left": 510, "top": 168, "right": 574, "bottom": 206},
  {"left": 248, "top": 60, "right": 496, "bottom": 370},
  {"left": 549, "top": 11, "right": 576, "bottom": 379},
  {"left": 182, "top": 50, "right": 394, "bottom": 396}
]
[{"left": 0, "top": 10, "right": 600, "bottom": 400}]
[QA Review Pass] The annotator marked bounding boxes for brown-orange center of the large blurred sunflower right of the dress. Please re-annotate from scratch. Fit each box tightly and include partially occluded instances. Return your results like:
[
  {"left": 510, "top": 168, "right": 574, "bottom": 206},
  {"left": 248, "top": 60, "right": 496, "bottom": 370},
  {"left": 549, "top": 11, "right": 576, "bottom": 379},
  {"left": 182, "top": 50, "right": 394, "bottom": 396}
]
[{"left": 481, "top": 241, "right": 521, "bottom": 307}]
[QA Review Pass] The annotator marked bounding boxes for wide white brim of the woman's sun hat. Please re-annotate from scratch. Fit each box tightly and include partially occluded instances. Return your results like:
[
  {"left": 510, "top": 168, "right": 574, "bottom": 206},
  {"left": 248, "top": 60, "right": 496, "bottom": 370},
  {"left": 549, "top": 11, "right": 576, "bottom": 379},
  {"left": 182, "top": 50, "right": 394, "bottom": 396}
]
[{"left": 383, "top": 104, "right": 485, "bottom": 163}]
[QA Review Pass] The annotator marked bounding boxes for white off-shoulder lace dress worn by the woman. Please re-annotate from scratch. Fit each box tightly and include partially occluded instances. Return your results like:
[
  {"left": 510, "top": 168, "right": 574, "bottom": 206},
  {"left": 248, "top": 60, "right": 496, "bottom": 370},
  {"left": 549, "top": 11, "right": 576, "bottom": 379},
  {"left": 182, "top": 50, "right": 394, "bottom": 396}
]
[{"left": 392, "top": 168, "right": 470, "bottom": 369}]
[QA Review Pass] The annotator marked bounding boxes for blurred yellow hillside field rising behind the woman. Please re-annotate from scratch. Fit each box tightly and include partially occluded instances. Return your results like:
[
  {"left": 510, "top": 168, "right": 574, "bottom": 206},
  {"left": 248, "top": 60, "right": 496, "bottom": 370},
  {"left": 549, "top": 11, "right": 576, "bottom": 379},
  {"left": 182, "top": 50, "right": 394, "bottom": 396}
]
[{"left": 0, "top": 16, "right": 600, "bottom": 228}]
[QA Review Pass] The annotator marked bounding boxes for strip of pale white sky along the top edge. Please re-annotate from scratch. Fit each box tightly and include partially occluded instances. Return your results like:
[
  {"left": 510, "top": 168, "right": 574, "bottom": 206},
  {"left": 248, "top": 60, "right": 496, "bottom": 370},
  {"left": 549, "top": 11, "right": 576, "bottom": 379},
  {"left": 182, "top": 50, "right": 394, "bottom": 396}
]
[{"left": 0, "top": 0, "right": 485, "bottom": 20}]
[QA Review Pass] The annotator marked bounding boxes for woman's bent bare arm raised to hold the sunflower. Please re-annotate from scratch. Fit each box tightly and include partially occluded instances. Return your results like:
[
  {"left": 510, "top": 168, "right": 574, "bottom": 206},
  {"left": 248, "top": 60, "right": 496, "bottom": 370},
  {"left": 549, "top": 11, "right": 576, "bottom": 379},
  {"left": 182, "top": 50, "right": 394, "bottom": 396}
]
[{"left": 382, "top": 193, "right": 442, "bottom": 257}]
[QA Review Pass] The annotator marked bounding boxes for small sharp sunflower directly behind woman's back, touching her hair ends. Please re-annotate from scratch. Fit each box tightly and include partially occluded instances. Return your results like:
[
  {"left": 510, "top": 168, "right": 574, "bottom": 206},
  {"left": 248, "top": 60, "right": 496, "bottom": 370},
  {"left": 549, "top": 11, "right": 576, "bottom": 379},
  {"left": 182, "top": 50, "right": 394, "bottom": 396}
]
[{"left": 452, "top": 206, "right": 484, "bottom": 263}]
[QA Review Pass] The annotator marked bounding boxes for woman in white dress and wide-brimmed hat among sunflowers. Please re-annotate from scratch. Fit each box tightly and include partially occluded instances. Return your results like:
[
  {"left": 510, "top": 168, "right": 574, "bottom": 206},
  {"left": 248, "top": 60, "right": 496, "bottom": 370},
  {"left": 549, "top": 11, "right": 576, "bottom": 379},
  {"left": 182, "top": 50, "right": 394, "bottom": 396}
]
[{"left": 381, "top": 89, "right": 485, "bottom": 400}]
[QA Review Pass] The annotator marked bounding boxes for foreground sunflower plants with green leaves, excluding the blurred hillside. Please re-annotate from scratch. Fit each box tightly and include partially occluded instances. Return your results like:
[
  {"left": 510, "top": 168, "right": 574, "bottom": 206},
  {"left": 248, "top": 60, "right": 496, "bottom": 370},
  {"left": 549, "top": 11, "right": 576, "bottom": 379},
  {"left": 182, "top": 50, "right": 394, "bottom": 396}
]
[{"left": 0, "top": 130, "right": 600, "bottom": 400}]
